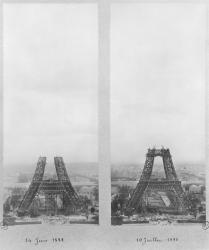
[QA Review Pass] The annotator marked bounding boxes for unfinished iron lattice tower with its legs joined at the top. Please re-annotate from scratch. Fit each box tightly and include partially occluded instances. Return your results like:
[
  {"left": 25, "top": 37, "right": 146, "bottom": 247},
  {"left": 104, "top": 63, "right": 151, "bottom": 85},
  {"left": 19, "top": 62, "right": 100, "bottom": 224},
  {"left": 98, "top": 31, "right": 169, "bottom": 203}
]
[{"left": 127, "top": 148, "right": 185, "bottom": 212}]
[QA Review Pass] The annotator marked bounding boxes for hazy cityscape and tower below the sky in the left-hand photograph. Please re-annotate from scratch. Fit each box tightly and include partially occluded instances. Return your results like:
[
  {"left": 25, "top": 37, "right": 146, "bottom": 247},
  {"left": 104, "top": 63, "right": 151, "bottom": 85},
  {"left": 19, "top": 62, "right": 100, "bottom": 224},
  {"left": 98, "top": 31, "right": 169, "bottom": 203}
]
[{"left": 4, "top": 157, "right": 99, "bottom": 225}]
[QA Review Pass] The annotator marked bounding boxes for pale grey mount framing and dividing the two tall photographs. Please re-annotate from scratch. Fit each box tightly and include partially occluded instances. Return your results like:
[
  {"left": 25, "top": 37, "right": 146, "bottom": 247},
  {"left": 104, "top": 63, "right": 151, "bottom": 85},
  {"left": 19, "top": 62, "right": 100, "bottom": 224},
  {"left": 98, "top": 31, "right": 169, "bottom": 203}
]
[{"left": 0, "top": 0, "right": 209, "bottom": 250}]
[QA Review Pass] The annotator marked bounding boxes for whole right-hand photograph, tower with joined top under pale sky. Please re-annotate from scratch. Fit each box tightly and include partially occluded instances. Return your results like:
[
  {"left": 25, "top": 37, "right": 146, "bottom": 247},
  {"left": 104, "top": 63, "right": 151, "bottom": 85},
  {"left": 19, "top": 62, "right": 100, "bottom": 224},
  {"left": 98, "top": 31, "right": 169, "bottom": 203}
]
[{"left": 111, "top": 3, "right": 206, "bottom": 225}]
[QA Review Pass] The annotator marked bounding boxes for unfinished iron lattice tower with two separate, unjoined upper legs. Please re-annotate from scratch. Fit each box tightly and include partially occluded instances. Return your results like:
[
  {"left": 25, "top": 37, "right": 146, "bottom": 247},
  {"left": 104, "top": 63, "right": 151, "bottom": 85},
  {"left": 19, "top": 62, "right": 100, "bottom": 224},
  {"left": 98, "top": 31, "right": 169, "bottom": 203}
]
[{"left": 18, "top": 157, "right": 80, "bottom": 214}]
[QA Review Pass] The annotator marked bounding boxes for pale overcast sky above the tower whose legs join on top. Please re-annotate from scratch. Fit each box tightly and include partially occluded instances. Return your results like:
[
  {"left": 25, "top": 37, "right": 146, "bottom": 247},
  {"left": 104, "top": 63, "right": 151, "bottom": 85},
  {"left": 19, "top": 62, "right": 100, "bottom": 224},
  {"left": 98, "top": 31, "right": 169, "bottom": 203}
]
[{"left": 111, "top": 4, "right": 206, "bottom": 162}]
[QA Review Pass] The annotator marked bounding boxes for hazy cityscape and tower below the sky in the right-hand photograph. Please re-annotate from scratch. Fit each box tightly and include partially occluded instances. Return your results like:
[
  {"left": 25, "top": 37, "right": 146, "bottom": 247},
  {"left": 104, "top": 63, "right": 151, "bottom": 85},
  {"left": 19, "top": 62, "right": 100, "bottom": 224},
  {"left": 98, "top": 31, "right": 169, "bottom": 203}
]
[{"left": 111, "top": 149, "right": 206, "bottom": 225}]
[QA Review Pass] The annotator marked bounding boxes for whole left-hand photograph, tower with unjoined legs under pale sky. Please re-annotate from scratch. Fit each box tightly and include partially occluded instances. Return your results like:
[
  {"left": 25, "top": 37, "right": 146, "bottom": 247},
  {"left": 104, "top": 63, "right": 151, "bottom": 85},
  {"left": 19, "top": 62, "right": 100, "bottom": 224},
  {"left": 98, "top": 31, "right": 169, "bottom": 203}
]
[{"left": 3, "top": 3, "right": 99, "bottom": 225}]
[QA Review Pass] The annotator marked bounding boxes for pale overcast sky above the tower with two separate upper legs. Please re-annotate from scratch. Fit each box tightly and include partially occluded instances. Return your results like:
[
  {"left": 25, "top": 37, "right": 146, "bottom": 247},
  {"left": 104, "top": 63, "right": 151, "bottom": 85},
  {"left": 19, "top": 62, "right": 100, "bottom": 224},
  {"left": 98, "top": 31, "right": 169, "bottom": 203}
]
[{"left": 3, "top": 4, "right": 98, "bottom": 164}]
